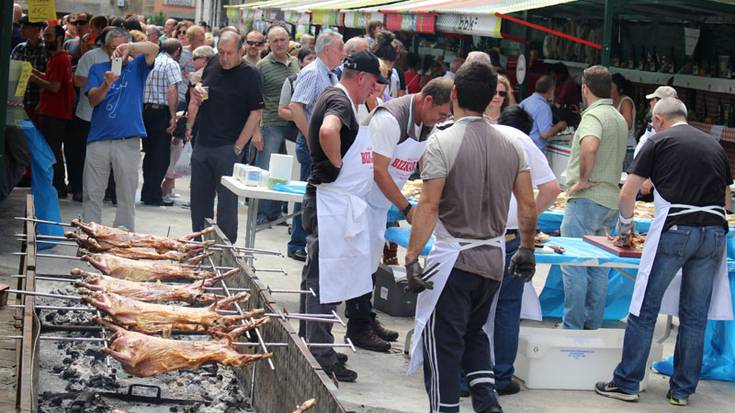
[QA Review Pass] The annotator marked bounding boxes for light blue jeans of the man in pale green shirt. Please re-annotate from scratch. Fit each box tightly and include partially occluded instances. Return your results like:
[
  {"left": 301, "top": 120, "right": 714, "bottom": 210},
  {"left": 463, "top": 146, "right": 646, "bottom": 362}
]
[{"left": 561, "top": 198, "right": 618, "bottom": 330}]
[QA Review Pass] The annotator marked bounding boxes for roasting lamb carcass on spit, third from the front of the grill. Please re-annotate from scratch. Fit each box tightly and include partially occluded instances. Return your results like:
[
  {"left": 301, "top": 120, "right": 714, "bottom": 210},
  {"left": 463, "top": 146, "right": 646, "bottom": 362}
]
[{"left": 71, "top": 268, "right": 237, "bottom": 304}]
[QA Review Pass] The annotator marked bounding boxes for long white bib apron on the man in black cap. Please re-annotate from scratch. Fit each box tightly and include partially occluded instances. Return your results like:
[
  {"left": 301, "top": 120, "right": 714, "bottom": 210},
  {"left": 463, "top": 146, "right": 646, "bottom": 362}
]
[{"left": 316, "top": 84, "right": 373, "bottom": 304}]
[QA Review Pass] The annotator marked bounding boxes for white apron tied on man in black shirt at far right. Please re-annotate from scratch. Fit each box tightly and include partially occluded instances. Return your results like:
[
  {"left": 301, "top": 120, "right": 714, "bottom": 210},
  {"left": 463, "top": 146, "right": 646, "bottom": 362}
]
[{"left": 629, "top": 188, "right": 733, "bottom": 320}]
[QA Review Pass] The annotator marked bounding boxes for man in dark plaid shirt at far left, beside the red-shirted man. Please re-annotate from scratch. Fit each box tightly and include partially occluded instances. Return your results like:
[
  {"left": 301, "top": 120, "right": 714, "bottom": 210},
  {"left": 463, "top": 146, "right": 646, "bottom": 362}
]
[{"left": 10, "top": 15, "right": 48, "bottom": 126}]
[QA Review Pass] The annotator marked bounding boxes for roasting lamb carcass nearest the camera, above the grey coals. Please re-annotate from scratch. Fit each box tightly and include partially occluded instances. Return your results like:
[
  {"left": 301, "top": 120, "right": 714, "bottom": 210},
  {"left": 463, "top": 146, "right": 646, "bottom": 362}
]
[{"left": 96, "top": 318, "right": 273, "bottom": 377}]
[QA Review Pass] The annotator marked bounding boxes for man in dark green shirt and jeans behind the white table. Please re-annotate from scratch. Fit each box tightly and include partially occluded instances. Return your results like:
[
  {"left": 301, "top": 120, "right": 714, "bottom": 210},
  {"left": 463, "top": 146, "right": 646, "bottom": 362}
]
[{"left": 253, "top": 25, "right": 301, "bottom": 224}]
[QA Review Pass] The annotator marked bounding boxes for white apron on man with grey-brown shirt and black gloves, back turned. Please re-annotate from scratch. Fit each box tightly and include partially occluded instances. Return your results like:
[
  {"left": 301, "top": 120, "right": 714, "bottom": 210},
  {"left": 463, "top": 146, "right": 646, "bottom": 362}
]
[{"left": 408, "top": 221, "right": 505, "bottom": 374}]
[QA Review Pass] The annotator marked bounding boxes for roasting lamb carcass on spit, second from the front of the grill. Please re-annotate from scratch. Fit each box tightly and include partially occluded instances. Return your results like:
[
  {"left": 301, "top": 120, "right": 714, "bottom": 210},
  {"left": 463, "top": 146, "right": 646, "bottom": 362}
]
[{"left": 79, "top": 289, "right": 268, "bottom": 336}]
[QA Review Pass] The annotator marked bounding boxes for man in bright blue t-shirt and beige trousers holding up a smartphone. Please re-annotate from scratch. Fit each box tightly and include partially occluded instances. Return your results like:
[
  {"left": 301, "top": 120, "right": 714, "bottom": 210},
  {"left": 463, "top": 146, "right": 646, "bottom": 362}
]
[{"left": 83, "top": 28, "right": 158, "bottom": 231}]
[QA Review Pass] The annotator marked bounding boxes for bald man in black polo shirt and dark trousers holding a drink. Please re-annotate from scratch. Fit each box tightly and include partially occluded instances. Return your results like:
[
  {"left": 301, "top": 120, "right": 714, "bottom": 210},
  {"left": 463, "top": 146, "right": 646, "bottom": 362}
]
[{"left": 187, "top": 31, "right": 264, "bottom": 243}]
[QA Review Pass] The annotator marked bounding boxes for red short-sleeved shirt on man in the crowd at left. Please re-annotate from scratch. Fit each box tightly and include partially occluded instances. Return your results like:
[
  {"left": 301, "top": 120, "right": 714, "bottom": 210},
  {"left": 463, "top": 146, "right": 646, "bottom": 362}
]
[{"left": 38, "top": 50, "right": 74, "bottom": 120}]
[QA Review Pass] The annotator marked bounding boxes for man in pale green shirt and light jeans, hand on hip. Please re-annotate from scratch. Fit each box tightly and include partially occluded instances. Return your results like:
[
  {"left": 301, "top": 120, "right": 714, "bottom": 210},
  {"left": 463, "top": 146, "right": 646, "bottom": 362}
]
[{"left": 561, "top": 66, "right": 628, "bottom": 330}]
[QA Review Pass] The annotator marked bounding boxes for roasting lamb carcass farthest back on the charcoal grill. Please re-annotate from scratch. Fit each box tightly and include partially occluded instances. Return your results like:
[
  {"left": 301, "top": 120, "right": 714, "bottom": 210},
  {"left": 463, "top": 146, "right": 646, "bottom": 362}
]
[{"left": 67, "top": 219, "right": 214, "bottom": 254}]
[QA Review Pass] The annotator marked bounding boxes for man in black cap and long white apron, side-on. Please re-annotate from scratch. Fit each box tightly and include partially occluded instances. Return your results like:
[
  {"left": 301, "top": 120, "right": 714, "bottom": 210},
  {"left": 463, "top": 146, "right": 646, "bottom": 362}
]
[{"left": 302, "top": 52, "right": 388, "bottom": 382}]
